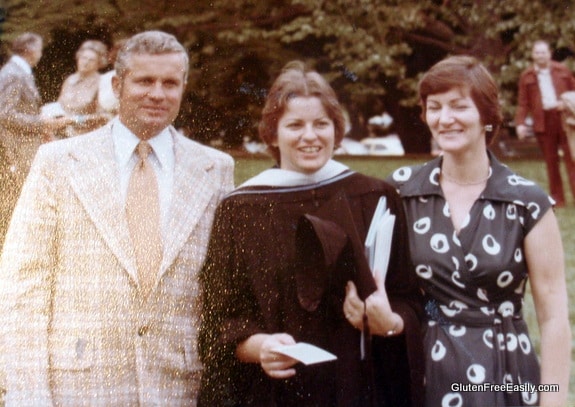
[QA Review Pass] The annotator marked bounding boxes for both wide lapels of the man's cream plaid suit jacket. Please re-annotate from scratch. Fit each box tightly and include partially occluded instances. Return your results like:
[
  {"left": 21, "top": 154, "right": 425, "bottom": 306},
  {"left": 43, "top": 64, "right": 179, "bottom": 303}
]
[{"left": 66, "top": 126, "right": 218, "bottom": 288}]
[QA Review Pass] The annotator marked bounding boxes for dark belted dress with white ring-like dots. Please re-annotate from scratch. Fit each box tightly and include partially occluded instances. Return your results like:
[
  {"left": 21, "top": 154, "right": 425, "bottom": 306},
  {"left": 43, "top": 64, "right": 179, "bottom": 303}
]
[{"left": 388, "top": 153, "right": 551, "bottom": 407}]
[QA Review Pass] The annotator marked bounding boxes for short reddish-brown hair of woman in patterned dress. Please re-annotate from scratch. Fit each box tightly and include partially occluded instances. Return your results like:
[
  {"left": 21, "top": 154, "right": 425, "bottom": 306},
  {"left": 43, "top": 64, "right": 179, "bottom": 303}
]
[{"left": 419, "top": 55, "right": 503, "bottom": 145}]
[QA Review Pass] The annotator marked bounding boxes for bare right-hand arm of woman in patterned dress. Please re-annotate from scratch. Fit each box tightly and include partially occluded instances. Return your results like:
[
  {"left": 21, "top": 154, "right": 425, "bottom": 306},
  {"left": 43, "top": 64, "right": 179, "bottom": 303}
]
[{"left": 524, "top": 210, "right": 571, "bottom": 406}]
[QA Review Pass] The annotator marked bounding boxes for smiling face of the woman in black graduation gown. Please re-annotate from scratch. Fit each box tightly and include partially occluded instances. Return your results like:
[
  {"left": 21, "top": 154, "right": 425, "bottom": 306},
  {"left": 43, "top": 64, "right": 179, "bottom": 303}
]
[{"left": 274, "top": 96, "right": 335, "bottom": 174}]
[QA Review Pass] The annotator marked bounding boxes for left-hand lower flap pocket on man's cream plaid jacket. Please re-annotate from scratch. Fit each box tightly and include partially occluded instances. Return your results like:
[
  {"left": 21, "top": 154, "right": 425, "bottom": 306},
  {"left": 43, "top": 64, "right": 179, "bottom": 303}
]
[{"left": 50, "top": 336, "right": 94, "bottom": 370}]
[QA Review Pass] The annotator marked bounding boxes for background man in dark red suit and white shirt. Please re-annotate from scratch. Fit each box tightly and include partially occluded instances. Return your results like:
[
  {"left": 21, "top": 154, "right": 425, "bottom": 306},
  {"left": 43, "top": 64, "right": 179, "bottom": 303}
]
[{"left": 515, "top": 41, "right": 575, "bottom": 207}]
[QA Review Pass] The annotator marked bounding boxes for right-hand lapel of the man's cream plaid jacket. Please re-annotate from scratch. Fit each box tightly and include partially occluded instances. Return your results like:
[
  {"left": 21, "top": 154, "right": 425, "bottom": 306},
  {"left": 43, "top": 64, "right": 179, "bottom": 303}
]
[{"left": 160, "top": 130, "right": 217, "bottom": 274}]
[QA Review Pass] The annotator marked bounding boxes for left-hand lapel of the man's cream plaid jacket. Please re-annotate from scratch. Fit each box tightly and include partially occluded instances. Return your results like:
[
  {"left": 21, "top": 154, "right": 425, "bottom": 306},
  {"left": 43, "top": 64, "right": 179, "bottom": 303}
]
[{"left": 70, "top": 126, "right": 137, "bottom": 281}]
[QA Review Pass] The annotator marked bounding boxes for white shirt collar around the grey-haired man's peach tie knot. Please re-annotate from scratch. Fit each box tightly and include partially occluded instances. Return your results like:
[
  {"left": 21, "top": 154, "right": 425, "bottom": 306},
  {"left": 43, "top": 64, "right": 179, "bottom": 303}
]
[{"left": 112, "top": 117, "right": 174, "bottom": 168}]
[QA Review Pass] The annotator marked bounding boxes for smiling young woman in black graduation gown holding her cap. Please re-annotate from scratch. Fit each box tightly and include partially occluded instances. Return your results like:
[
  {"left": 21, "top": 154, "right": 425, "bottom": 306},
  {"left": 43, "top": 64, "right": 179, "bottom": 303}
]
[{"left": 199, "top": 61, "right": 423, "bottom": 406}]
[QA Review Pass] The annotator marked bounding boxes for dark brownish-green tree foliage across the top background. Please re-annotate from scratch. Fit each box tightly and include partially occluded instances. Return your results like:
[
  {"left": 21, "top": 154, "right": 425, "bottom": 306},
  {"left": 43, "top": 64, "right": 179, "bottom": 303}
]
[{"left": 0, "top": 0, "right": 575, "bottom": 151}]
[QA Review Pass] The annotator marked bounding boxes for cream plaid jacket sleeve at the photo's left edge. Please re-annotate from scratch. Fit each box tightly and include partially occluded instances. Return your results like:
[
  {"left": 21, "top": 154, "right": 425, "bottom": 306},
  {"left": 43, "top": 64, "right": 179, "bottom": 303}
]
[{"left": 0, "top": 149, "right": 58, "bottom": 406}]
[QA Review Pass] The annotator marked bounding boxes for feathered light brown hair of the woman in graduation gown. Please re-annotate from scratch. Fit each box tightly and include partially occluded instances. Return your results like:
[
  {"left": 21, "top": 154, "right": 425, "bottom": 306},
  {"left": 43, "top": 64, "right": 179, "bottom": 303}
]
[{"left": 258, "top": 60, "right": 345, "bottom": 163}]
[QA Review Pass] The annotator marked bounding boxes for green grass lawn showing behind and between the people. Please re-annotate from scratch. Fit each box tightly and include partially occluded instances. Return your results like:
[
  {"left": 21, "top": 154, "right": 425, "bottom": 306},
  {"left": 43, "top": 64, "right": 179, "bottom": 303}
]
[{"left": 236, "top": 157, "right": 575, "bottom": 406}]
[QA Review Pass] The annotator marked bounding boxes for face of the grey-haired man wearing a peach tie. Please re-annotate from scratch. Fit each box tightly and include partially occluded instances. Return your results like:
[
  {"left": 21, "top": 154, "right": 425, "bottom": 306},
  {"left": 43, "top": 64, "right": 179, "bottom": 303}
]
[{"left": 112, "top": 53, "right": 186, "bottom": 140}]
